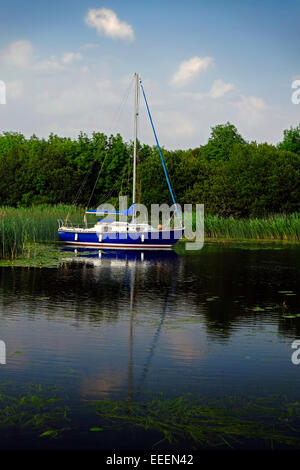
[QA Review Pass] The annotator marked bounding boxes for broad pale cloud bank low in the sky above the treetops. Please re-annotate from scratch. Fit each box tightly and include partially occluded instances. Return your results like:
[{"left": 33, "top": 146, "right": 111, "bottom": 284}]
[{"left": 0, "top": 41, "right": 290, "bottom": 149}]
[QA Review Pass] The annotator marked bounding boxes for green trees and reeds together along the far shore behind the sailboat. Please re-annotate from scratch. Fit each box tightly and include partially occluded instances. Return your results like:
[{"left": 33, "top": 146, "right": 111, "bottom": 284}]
[{"left": 0, "top": 122, "right": 300, "bottom": 260}]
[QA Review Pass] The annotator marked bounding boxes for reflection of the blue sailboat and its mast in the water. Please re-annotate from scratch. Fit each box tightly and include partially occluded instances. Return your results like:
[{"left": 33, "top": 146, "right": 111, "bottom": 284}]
[{"left": 62, "top": 246, "right": 181, "bottom": 402}]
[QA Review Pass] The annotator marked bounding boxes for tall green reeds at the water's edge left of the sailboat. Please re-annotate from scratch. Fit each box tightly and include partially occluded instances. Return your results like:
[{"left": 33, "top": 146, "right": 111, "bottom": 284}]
[{"left": 0, "top": 204, "right": 84, "bottom": 259}]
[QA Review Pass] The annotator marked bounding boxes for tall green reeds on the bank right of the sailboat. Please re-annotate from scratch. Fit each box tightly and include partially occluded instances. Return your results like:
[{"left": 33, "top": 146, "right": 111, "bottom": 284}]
[{"left": 202, "top": 213, "right": 300, "bottom": 241}]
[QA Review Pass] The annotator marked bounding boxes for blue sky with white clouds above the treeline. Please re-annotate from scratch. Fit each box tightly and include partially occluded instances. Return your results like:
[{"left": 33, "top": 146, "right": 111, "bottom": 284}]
[{"left": 0, "top": 0, "right": 300, "bottom": 148}]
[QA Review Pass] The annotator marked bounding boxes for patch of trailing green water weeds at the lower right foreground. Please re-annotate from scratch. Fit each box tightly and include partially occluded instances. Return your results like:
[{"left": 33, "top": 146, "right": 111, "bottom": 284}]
[{"left": 88, "top": 396, "right": 300, "bottom": 448}]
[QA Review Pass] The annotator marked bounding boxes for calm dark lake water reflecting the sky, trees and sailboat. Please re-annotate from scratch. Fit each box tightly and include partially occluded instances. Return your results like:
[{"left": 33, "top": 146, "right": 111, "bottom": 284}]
[{"left": 0, "top": 243, "right": 300, "bottom": 450}]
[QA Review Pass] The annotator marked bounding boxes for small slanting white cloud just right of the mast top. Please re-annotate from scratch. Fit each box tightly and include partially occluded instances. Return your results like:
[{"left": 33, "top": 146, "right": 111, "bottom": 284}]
[{"left": 171, "top": 56, "right": 214, "bottom": 87}]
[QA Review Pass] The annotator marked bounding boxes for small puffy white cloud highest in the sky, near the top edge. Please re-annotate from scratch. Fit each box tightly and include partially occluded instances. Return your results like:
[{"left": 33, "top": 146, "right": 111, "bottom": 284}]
[{"left": 85, "top": 8, "right": 134, "bottom": 41}]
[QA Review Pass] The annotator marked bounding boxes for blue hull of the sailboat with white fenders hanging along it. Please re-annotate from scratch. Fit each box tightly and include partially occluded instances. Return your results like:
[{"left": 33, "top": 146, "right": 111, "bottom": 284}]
[{"left": 58, "top": 229, "right": 184, "bottom": 249}]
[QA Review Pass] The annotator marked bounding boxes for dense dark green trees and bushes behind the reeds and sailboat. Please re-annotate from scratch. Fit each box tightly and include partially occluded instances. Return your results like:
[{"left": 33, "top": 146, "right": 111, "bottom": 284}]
[{"left": 0, "top": 123, "right": 300, "bottom": 217}]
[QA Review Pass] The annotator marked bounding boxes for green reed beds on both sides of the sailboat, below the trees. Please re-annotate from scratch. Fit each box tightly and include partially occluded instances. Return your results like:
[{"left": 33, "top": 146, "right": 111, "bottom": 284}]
[{"left": 0, "top": 204, "right": 300, "bottom": 266}]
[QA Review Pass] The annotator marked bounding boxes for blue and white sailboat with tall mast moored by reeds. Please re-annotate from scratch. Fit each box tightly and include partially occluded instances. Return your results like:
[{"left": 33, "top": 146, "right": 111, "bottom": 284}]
[{"left": 58, "top": 73, "right": 184, "bottom": 250}]
